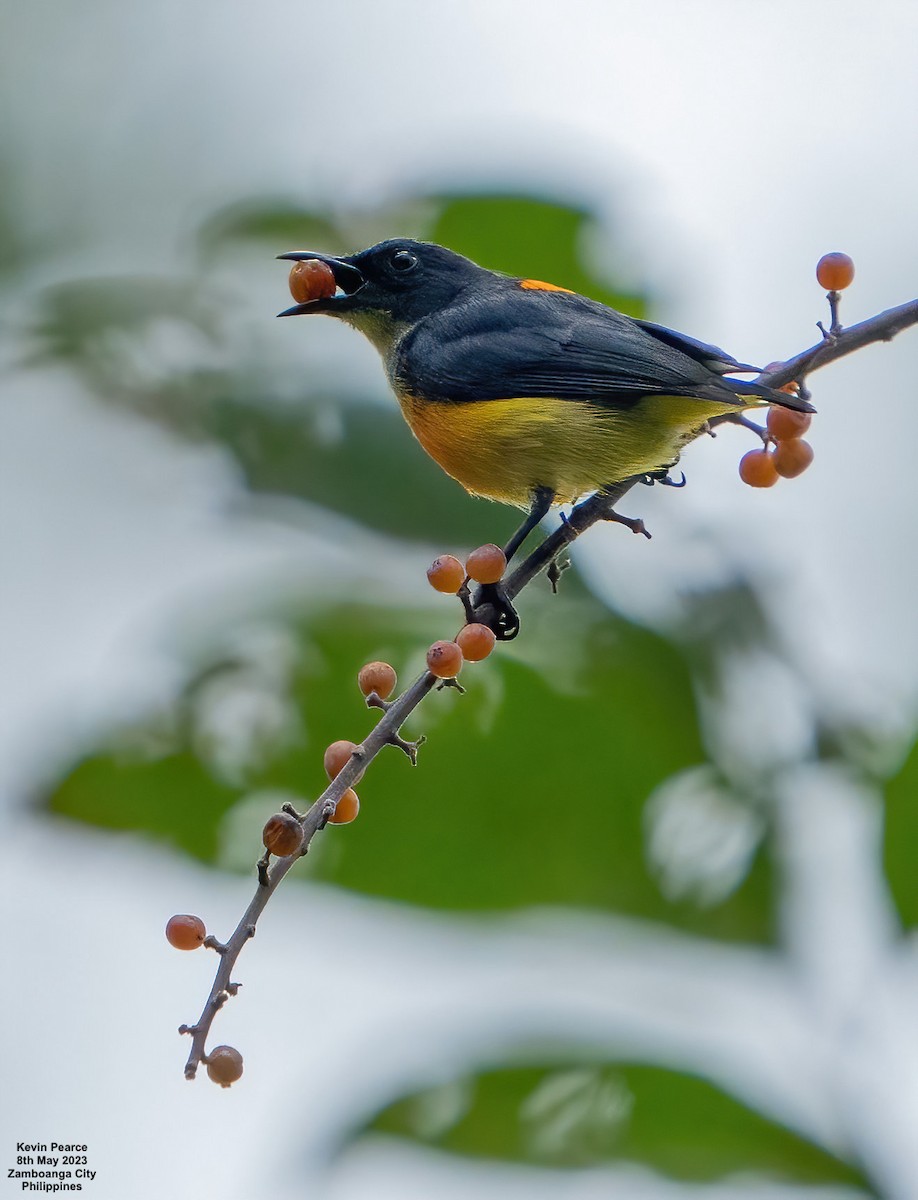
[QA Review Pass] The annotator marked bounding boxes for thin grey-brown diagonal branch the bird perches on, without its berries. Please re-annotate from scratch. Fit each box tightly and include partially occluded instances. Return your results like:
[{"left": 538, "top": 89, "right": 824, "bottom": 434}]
[{"left": 179, "top": 288, "right": 918, "bottom": 1079}]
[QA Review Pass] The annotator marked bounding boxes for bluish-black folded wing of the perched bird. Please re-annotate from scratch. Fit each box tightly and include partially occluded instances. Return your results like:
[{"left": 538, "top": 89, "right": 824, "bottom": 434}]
[{"left": 395, "top": 288, "right": 791, "bottom": 407}]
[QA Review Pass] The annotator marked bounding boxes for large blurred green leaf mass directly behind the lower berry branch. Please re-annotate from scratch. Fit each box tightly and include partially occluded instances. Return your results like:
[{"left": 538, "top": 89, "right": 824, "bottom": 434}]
[{"left": 42, "top": 587, "right": 770, "bottom": 941}]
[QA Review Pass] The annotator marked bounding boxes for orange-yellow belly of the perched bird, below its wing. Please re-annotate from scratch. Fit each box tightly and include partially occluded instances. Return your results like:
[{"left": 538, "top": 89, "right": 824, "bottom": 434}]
[{"left": 398, "top": 395, "right": 740, "bottom": 508}]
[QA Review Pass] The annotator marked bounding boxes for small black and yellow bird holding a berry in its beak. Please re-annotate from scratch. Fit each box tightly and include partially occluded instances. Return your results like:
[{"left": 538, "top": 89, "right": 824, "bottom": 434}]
[{"left": 277, "top": 238, "right": 812, "bottom": 558}]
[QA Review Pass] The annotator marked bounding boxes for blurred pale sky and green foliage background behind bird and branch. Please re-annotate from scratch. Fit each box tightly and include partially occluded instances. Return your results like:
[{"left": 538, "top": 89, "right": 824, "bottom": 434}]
[{"left": 0, "top": 0, "right": 918, "bottom": 1200}]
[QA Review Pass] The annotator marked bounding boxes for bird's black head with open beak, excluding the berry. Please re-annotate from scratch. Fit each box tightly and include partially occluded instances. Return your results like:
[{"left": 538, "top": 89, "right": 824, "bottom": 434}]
[{"left": 278, "top": 238, "right": 490, "bottom": 325}]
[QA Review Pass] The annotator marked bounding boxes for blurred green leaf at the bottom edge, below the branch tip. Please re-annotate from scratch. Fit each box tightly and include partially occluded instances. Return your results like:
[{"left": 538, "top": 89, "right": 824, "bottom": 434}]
[{"left": 368, "top": 1062, "right": 865, "bottom": 1187}]
